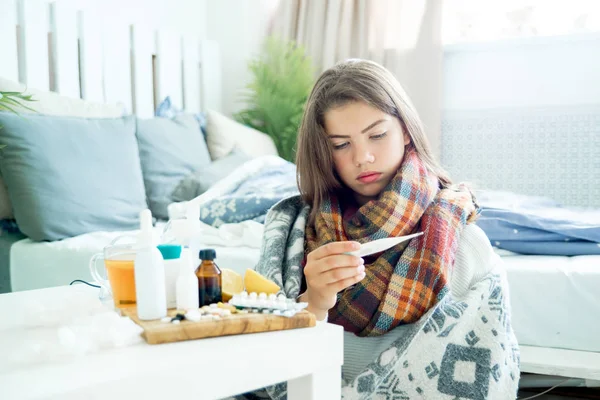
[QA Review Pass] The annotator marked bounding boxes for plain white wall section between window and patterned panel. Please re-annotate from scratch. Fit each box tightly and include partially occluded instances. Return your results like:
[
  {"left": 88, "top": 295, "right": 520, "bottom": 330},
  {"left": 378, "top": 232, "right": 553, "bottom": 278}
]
[{"left": 443, "top": 34, "right": 600, "bottom": 110}]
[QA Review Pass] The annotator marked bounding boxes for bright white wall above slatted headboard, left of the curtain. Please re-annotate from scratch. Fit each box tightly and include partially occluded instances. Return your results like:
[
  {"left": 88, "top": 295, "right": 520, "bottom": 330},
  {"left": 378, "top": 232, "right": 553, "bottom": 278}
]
[{"left": 63, "top": 0, "right": 280, "bottom": 115}]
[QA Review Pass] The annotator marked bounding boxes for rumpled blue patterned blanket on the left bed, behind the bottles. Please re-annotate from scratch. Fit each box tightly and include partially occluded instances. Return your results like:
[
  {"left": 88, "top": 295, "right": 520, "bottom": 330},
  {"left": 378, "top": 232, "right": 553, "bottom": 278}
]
[{"left": 200, "top": 156, "right": 299, "bottom": 227}]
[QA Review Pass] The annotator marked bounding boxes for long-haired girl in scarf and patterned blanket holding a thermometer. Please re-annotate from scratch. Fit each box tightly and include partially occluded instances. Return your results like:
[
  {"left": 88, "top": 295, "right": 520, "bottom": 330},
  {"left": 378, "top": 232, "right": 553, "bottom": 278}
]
[{"left": 251, "top": 60, "right": 518, "bottom": 398}]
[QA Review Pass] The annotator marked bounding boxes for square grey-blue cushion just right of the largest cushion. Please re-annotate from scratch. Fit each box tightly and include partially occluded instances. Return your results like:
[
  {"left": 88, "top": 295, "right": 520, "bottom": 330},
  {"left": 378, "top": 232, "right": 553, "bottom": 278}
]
[{"left": 137, "top": 114, "right": 211, "bottom": 219}]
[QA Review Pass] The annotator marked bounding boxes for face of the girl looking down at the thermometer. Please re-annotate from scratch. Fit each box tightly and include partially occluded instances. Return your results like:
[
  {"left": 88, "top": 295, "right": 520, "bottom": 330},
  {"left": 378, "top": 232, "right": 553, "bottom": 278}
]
[{"left": 324, "top": 102, "right": 410, "bottom": 205}]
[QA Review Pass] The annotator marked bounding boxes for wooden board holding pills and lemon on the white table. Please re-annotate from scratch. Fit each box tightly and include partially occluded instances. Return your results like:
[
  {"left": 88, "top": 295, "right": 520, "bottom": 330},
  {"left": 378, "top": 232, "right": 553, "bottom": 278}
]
[{"left": 121, "top": 307, "right": 316, "bottom": 344}]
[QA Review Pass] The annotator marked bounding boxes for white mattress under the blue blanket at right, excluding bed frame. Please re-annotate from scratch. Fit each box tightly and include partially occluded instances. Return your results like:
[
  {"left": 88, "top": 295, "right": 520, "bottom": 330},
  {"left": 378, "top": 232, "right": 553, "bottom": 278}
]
[{"left": 500, "top": 253, "right": 600, "bottom": 352}]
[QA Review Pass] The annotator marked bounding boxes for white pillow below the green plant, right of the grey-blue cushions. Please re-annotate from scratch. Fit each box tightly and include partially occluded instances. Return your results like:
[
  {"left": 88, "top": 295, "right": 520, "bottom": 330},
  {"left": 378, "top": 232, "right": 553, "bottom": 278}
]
[{"left": 206, "top": 110, "right": 278, "bottom": 160}]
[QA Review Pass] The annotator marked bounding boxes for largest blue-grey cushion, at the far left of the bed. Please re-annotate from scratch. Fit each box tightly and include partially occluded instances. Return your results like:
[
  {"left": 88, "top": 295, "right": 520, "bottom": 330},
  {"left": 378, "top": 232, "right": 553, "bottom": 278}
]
[{"left": 0, "top": 112, "right": 146, "bottom": 241}]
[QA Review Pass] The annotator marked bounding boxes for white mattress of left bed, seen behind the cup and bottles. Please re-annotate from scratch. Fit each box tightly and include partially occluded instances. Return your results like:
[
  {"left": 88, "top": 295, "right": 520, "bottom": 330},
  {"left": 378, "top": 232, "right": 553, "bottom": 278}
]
[{"left": 10, "top": 224, "right": 262, "bottom": 292}]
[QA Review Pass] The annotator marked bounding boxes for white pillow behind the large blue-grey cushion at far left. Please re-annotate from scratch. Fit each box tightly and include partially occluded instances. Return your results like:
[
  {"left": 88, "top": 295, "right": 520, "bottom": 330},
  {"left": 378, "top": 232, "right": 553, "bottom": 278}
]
[{"left": 0, "top": 77, "right": 125, "bottom": 219}]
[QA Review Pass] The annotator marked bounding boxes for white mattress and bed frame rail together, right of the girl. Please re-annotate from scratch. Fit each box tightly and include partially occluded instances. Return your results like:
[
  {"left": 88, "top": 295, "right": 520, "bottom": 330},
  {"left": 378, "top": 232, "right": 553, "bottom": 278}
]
[{"left": 498, "top": 250, "right": 600, "bottom": 386}]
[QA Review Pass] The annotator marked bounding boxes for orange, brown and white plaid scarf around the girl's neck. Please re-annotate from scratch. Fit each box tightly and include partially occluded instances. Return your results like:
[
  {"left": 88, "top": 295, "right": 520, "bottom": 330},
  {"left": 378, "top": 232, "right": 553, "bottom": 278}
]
[{"left": 305, "top": 147, "right": 477, "bottom": 336}]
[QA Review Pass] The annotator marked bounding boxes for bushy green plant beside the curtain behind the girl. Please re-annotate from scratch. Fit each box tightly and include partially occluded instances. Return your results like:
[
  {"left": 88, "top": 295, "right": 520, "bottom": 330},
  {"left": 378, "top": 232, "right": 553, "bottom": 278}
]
[{"left": 234, "top": 36, "right": 314, "bottom": 162}]
